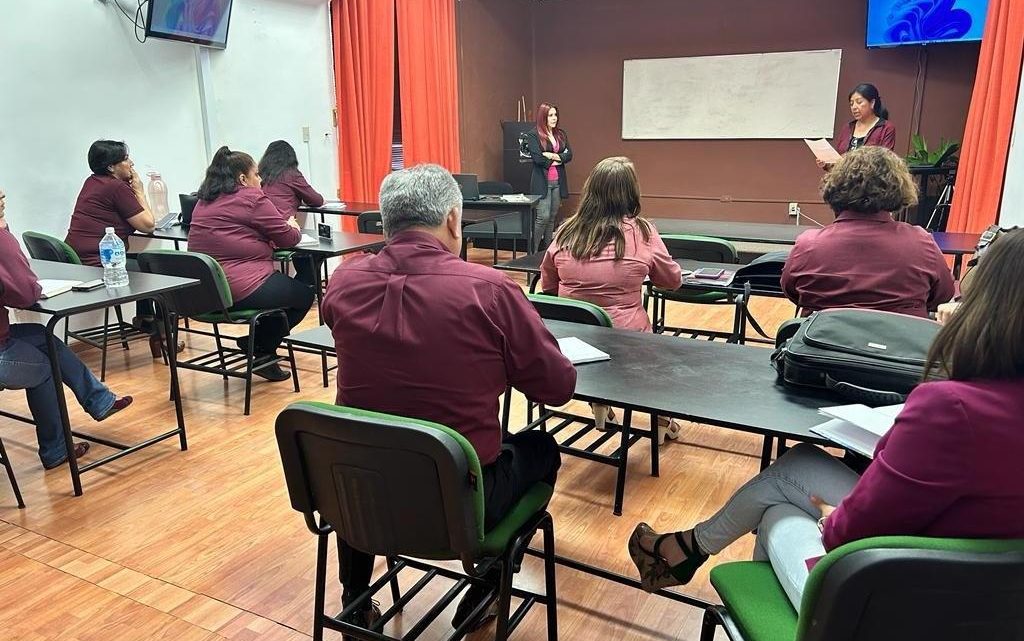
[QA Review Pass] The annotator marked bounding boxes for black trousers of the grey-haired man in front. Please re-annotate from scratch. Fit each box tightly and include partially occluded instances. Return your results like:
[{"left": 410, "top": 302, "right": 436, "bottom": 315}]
[{"left": 338, "top": 430, "right": 562, "bottom": 601}]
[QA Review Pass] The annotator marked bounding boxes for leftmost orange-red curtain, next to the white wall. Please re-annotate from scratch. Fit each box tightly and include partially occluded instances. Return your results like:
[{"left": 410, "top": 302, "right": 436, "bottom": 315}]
[{"left": 331, "top": 0, "right": 394, "bottom": 224}]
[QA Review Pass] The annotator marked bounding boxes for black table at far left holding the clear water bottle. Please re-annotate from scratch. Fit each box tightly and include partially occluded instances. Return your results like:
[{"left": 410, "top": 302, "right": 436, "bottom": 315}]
[{"left": 27, "top": 260, "right": 199, "bottom": 496}]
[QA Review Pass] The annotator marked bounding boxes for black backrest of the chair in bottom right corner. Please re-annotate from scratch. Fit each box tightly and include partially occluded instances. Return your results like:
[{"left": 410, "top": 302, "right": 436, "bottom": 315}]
[{"left": 797, "top": 537, "right": 1024, "bottom": 641}]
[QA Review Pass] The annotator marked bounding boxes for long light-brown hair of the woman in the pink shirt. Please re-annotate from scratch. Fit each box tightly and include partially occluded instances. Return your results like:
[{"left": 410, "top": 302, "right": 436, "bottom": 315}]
[{"left": 555, "top": 156, "right": 651, "bottom": 260}]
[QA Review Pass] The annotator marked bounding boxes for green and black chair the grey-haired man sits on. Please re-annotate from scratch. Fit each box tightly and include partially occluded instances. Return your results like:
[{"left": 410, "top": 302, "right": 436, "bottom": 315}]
[{"left": 275, "top": 402, "right": 558, "bottom": 641}]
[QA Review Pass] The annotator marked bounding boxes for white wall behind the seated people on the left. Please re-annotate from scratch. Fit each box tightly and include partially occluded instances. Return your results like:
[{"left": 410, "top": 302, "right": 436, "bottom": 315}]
[{"left": 0, "top": 0, "right": 338, "bottom": 241}]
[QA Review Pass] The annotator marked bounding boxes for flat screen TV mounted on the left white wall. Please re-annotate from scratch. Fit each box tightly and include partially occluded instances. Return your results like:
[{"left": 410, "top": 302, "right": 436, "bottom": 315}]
[{"left": 145, "top": 0, "right": 231, "bottom": 49}]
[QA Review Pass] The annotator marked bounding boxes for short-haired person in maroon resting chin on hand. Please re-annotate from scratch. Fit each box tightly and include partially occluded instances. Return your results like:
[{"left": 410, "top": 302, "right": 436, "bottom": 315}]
[{"left": 65, "top": 140, "right": 171, "bottom": 358}]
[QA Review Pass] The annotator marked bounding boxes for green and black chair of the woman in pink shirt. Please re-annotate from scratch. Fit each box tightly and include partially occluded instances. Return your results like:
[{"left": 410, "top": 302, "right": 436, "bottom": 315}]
[{"left": 502, "top": 294, "right": 658, "bottom": 515}]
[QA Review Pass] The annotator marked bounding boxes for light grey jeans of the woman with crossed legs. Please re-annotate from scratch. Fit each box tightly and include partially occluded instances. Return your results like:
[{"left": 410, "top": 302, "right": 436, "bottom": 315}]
[{"left": 693, "top": 443, "right": 859, "bottom": 611}]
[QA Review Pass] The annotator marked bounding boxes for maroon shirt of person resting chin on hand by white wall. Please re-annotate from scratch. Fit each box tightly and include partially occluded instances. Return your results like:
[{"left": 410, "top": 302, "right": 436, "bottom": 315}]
[{"left": 65, "top": 175, "right": 143, "bottom": 267}]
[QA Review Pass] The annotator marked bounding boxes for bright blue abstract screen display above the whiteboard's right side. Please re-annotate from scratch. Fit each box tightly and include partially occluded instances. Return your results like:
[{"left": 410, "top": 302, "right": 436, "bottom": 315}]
[{"left": 867, "top": 0, "right": 988, "bottom": 47}]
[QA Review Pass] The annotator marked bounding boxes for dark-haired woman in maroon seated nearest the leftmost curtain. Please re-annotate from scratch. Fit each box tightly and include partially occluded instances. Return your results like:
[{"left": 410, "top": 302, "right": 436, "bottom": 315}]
[{"left": 259, "top": 140, "right": 324, "bottom": 287}]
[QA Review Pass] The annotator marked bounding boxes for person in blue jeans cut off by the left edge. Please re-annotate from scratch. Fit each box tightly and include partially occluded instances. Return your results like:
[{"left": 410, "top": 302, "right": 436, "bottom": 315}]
[{"left": 0, "top": 187, "right": 132, "bottom": 470}]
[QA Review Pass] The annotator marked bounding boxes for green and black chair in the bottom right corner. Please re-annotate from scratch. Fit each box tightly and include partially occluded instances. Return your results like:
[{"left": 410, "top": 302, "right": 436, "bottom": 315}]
[{"left": 700, "top": 537, "right": 1024, "bottom": 641}]
